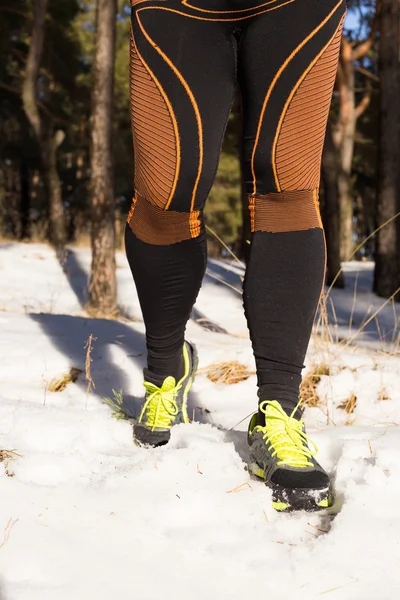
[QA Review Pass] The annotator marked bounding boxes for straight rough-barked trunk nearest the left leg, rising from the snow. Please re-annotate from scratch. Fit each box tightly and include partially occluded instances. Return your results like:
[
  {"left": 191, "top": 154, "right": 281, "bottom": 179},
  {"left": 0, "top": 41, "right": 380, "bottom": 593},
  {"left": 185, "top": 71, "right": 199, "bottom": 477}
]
[{"left": 89, "top": 0, "right": 117, "bottom": 316}]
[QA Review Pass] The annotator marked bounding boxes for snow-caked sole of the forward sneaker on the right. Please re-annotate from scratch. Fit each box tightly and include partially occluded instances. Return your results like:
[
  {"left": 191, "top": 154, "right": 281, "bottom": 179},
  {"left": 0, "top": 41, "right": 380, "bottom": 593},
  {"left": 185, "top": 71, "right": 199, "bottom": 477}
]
[{"left": 249, "top": 463, "right": 334, "bottom": 512}]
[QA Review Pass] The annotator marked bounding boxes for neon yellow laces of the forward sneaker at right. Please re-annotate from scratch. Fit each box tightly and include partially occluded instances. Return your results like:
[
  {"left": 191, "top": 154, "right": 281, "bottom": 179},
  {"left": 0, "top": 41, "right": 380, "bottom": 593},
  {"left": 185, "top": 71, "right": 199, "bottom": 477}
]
[{"left": 255, "top": 400, "right": 318, "bottom": 467}]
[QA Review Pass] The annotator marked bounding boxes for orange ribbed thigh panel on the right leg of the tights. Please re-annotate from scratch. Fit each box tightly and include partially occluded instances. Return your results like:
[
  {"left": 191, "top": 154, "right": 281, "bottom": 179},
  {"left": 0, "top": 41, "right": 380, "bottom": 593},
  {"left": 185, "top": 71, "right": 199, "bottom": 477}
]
[{"left": 276, "top": 17, "right": 344, "bottom": 190}]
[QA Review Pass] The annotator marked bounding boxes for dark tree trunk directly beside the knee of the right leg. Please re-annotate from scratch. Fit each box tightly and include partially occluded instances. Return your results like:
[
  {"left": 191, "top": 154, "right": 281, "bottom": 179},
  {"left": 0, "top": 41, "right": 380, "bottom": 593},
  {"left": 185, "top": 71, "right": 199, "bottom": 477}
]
[{"left": 321, "top": 122, "right": 344, "bottom": 288}]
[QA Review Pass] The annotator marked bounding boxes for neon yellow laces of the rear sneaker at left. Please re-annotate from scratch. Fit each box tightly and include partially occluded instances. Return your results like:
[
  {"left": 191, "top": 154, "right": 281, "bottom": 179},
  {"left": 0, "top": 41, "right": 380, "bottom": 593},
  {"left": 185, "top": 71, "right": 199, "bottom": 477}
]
[{"left": 139, "top": 377, "right": 181, "bottom": 431}]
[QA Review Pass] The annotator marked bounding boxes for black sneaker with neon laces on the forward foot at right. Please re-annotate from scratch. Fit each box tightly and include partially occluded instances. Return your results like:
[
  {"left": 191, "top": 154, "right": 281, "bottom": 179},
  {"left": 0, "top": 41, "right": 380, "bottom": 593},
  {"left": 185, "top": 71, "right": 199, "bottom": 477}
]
[{"left": 248, "top": 400, "right": 333, "bottom": 511}]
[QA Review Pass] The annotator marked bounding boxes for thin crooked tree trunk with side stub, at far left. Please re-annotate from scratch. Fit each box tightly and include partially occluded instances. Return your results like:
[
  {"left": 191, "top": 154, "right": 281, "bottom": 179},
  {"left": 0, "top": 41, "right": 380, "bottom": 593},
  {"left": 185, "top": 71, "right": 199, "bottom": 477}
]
[{"left": 22, "top": 0, "right": 65, "bottom": 250}]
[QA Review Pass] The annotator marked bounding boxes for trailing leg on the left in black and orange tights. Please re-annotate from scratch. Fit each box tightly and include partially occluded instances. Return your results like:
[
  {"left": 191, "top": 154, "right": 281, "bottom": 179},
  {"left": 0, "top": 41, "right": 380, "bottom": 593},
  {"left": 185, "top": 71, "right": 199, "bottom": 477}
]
[{"left": 125, "top": 0, "right": 236, "bottom": 443}]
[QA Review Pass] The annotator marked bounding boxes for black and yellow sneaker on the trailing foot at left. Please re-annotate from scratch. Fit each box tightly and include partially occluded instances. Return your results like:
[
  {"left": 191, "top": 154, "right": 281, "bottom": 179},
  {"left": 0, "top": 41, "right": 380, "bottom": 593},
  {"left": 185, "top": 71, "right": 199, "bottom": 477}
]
[{"left": 133, "top": 342, "right": 198, "bottom": 447}]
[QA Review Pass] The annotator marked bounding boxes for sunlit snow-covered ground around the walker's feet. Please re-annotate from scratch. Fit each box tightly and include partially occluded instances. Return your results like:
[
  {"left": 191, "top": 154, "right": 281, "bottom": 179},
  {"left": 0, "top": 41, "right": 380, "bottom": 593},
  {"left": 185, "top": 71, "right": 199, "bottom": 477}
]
[{"left": 0, "top": 243, "right": 400, "bottom": 600}]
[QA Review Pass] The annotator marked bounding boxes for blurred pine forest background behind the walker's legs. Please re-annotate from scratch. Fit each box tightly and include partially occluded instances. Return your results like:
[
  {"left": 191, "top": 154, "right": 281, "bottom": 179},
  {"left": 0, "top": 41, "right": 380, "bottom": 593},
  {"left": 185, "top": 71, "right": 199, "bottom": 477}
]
[{"left": 0, "top": 0, "right": 400, "bottom": 315}]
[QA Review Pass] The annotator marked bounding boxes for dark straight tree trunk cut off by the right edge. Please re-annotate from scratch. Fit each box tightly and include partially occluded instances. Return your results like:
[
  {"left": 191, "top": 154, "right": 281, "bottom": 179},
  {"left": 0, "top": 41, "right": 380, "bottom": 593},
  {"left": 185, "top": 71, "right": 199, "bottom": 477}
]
[{"left": 375, "top": 0, "right": 400, "bottom": 300}]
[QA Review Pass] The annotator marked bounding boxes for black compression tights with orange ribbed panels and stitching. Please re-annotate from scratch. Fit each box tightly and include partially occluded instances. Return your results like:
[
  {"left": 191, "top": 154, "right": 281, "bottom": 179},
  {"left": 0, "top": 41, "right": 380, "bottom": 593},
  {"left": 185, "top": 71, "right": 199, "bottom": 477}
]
[{"left": 126, "top": 0, "right": 345, "bottom": 410}]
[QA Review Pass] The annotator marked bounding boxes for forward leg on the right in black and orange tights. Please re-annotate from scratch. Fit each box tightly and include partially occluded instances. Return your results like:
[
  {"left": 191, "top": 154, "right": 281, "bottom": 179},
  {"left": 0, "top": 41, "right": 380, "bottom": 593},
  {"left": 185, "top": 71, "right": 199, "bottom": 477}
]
[{"left": 239, "top": 0, "right": 345, "bottom": 416}]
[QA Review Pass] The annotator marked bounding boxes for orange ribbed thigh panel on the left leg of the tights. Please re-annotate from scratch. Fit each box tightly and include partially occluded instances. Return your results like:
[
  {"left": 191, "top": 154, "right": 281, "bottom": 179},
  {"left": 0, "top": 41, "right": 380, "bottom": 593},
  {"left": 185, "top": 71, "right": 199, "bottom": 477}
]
[{"left": 130, "top": 37, "right": 177, "bottom": 208}]
